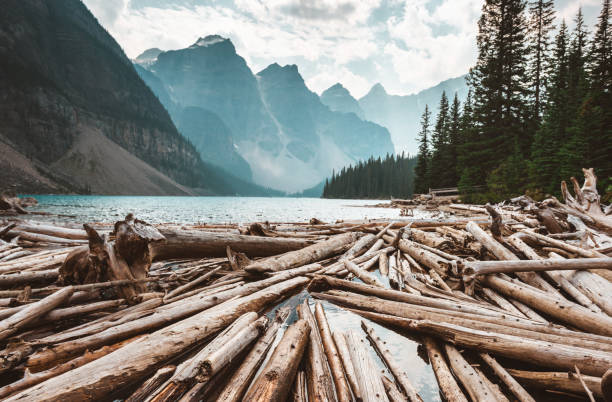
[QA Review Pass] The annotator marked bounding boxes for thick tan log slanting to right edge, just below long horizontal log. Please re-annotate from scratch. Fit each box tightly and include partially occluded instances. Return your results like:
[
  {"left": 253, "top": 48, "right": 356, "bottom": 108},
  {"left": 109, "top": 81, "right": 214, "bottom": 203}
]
[{"left": 482, "top": 275, "right": 612, "bottom": 336}]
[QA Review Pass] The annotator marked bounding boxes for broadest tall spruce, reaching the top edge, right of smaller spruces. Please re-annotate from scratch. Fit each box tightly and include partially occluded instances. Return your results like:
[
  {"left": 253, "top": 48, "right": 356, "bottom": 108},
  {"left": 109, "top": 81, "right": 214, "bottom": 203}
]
[{"left": 460, "top": 0, "right": 533, "bottom": 192}]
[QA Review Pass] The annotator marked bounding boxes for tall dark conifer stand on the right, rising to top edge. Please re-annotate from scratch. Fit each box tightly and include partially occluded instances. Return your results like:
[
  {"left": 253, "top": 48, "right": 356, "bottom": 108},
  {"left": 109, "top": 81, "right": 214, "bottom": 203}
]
[{"left": 414, "top": 0, "right": 612, "bottom": 202}]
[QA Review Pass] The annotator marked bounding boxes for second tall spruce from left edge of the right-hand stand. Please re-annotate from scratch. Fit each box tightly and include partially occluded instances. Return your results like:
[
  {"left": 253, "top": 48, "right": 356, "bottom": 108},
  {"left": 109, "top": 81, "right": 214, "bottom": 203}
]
[{"left": 429, "top": 91, "right": 450, "bottom": 187}]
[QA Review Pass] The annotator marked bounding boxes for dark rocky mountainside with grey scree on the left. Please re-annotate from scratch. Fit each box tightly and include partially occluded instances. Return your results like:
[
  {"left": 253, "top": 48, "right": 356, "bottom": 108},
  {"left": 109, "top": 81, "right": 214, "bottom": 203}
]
[{"left": 0, "top": 0, "right": 268, "bottom": 194}]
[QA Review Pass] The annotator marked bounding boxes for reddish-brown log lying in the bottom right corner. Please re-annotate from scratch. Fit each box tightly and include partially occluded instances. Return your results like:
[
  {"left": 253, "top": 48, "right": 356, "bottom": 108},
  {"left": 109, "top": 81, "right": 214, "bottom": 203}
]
[{"left": 508, "top": 369, "right": 604, "bottom": 398}]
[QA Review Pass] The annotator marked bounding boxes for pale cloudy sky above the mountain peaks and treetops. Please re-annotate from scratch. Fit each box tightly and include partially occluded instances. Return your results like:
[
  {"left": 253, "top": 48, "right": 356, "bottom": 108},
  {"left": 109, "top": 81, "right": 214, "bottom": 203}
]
[{"left": 83, "top": 0, "right": 601, "bottom": 98}]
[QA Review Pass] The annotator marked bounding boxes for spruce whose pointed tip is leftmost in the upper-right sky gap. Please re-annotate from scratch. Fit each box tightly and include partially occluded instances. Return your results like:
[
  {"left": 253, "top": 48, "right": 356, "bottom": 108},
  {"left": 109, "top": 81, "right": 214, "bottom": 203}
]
[{"left": 530, "top": 21, "right": 570, "bottom": 193}]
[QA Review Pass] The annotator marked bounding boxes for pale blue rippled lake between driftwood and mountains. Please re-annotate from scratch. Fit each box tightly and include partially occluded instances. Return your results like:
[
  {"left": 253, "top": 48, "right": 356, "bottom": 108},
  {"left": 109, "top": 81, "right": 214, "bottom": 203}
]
[{"left": 21, "top": 195, "right": 425, "bottom": 223}]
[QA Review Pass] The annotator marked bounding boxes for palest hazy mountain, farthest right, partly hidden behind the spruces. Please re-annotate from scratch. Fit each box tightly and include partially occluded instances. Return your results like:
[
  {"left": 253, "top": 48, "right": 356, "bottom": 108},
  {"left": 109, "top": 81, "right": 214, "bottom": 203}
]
[{"left": 358, "top": 76, "right": 468, "bottom": 154}]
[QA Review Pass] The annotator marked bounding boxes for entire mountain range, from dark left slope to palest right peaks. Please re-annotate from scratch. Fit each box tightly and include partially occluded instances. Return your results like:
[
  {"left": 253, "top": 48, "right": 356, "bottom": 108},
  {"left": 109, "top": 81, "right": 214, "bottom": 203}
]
[{"left": 0, "top": 0, "right": 462, "bottom": 195}]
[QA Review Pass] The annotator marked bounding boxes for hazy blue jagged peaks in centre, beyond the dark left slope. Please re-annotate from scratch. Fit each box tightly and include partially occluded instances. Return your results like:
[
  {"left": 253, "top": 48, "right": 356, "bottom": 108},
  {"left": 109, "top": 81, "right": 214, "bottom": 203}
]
[{"left": 136, "top": 35, "right": 393, "bottom": 192}]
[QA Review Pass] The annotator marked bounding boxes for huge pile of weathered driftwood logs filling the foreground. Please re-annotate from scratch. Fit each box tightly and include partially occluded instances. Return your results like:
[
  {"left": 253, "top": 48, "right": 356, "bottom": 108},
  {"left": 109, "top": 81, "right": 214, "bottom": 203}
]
[{"left": 0, "top": 171, "right": 612, "bottom": 401}]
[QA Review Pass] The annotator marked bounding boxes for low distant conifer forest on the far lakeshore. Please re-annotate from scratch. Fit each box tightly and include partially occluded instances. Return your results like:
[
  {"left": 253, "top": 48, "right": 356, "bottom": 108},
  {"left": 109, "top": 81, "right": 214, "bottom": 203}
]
[{"left": 323, "top": 154, "right": 416, "bottom": 198}]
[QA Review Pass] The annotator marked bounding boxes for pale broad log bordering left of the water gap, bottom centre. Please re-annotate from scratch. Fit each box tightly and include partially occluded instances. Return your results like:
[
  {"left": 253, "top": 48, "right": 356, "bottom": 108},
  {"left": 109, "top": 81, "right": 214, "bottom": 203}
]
[{"left": 345, "top": 330, "right": 389, "bottom": 402}]
